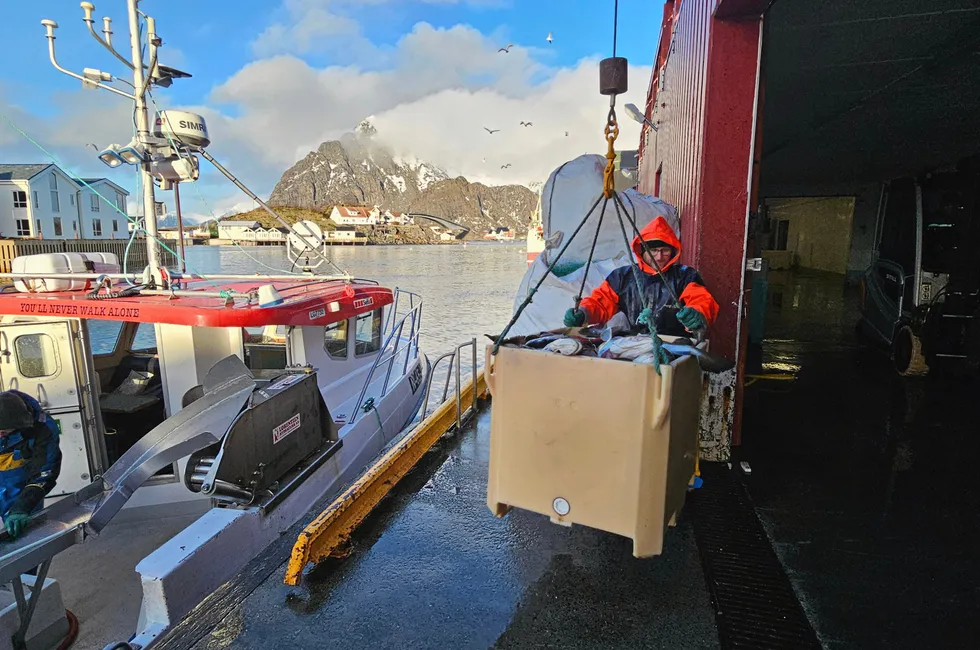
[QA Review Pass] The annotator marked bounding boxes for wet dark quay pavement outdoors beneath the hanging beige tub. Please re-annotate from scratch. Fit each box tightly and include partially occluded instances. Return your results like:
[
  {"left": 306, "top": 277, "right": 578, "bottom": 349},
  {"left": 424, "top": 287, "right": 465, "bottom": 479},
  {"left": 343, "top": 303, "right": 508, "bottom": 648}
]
[{"left": 186, "top": 412, "right": 718, "bottom": 650}]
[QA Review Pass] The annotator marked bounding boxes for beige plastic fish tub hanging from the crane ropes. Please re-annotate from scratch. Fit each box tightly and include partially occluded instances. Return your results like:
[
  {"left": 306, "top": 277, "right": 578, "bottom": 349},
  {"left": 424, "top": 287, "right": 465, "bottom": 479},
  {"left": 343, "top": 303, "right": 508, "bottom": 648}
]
[{"left": 484, "top": 337, "right": 701, "bottom": 557}]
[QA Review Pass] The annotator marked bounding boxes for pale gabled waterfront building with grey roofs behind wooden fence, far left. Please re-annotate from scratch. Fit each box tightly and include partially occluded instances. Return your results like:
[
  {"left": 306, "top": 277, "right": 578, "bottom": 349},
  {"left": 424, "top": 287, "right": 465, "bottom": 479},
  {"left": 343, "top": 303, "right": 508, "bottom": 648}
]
[{"left": 0, "top": 164, "right": 129, "bottom": 239}]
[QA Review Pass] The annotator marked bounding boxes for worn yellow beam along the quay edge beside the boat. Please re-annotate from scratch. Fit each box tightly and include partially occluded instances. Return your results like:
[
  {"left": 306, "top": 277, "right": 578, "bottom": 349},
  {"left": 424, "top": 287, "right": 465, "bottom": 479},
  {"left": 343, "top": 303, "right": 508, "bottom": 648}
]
[{"left": 284, "top": 372, "right": 487, "bottom": 585}]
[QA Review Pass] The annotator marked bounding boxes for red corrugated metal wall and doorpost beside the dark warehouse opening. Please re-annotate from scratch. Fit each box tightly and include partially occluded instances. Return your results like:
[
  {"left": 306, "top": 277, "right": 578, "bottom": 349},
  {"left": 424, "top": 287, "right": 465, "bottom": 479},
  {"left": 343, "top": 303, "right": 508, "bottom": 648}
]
[{"left": 639, "top": 0, "right": 764, "bottom": 356}]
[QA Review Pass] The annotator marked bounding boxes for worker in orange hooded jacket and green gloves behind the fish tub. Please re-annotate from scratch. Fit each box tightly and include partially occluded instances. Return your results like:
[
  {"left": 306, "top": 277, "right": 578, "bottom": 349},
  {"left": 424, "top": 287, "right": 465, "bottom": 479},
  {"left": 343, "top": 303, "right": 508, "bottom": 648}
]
[{"left": 564, "top": 217, "right": 718, "bottom": 335}]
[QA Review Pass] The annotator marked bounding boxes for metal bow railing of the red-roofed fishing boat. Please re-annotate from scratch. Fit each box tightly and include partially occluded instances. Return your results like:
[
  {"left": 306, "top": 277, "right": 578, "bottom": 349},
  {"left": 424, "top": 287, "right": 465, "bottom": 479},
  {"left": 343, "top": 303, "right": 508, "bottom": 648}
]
[{"left": 347, "top": 288, "right": 422, "bottom": 424}]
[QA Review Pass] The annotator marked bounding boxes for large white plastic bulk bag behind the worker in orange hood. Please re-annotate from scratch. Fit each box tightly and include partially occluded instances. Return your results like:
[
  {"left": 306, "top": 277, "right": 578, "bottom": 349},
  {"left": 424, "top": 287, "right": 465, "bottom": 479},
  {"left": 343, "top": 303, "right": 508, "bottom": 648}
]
[{"left": 507, "top": 154, "right": 680, "bottom": 337}]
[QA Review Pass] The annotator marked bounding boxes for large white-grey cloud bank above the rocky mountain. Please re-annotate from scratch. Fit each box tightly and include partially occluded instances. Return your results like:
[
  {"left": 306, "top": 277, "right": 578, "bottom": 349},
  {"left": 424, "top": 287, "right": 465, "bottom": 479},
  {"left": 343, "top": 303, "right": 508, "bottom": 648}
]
[{"left": 194, "top": 23, "right": 650, "bottom": 190}]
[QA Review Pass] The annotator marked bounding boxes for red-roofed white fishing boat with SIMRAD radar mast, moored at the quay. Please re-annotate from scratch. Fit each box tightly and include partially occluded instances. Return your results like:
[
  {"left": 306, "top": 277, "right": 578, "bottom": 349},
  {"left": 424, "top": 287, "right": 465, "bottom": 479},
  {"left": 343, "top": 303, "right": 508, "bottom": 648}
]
[{"left": 0, "top": 0, "right": 430, "bottom": 648}]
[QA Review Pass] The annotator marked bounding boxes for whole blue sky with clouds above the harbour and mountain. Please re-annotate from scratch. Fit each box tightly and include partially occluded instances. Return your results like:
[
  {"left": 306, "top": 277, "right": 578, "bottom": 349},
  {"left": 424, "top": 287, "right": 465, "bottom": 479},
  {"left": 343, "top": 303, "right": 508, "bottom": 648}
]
[{"left": 0, "top": 0, "right": 662, "bottom": 216}]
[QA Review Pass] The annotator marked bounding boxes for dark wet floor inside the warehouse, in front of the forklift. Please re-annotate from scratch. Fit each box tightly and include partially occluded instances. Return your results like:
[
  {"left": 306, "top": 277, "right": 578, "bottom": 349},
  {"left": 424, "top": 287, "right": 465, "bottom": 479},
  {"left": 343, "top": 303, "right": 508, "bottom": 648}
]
[{"left": 736, "top": 274, "right": 980, "bottom": 648}]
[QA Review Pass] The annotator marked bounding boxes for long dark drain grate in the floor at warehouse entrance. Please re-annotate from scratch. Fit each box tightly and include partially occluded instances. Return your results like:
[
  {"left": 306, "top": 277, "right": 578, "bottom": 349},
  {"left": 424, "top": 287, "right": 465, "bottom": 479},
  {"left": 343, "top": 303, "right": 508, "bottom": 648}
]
[{"left": 688, "top": 463, "right": 821, "bottom": 650}]
